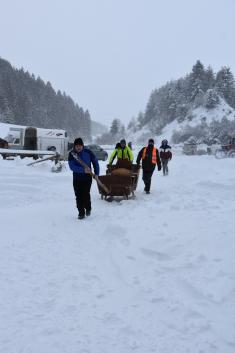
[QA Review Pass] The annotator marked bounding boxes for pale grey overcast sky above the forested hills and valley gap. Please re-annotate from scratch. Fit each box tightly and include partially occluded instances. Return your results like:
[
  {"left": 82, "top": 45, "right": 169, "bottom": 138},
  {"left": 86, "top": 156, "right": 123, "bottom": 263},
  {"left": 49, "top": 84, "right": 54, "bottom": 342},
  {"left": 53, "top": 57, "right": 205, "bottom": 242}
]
[{"left": 0, "top": 0, "right": 235, "bottom": 125}]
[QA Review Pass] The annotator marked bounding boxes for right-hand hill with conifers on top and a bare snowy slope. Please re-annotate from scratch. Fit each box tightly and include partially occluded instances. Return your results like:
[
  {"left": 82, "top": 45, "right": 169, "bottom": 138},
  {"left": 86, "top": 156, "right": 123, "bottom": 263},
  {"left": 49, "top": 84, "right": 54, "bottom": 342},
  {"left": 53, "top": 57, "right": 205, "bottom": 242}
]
[{"left": 127, "top": 60, "right": 235, "bottom": 143}]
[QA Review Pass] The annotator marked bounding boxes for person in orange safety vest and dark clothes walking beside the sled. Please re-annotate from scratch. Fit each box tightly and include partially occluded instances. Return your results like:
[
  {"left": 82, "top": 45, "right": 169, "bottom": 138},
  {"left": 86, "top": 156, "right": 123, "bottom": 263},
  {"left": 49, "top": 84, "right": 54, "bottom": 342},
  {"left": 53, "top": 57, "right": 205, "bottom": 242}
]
[{"left": 136, "top": 139, "right": 162, "bottom": 194}]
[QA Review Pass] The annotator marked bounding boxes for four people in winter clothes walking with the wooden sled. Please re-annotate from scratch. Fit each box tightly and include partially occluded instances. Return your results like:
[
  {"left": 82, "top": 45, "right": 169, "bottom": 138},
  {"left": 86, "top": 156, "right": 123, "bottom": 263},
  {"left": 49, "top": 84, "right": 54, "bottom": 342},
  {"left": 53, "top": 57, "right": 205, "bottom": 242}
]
[{"left": 68, "top": 138, "right": 172, "bottom": 219}]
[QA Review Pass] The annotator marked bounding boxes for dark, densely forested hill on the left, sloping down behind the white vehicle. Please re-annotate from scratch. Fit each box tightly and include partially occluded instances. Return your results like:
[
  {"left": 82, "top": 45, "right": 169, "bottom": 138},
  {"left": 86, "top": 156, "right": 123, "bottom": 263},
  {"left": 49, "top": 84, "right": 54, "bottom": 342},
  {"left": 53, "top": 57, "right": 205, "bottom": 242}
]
[{"left": 0, "top": 58, "right": 92, "bottom": 140}]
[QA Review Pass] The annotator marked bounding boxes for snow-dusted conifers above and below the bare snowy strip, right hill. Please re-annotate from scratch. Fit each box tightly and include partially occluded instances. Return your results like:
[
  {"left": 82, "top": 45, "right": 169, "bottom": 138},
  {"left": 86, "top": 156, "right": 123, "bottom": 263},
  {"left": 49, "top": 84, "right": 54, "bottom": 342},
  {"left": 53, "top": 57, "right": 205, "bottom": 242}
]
[{"left": 127, "top": 60, "right": 235, "bottom": 143}]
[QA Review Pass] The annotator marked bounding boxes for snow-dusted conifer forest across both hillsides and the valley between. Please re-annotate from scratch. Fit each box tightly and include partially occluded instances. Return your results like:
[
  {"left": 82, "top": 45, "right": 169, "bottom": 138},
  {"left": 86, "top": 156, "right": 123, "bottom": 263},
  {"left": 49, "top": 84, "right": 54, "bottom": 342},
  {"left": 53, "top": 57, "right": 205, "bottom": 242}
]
[{"left": 0, "top": 58, "right": 235, "bottom": 144}]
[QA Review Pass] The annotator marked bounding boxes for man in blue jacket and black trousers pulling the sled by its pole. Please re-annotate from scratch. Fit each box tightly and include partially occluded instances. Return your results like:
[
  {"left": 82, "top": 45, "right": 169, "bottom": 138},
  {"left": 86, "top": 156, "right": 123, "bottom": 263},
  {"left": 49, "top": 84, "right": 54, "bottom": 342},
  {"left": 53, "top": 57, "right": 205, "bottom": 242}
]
[{"left": 68, "top": 137, "right": 100, "bottom": 219}]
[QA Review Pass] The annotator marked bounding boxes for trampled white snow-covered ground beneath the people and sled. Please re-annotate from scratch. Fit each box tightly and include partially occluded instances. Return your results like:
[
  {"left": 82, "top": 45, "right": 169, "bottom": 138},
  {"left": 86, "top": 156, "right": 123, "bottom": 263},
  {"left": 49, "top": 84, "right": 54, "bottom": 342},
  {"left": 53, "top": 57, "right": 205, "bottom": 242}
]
[{"left": 0, "top": 151, "right": 235, "bottom": 353}]
